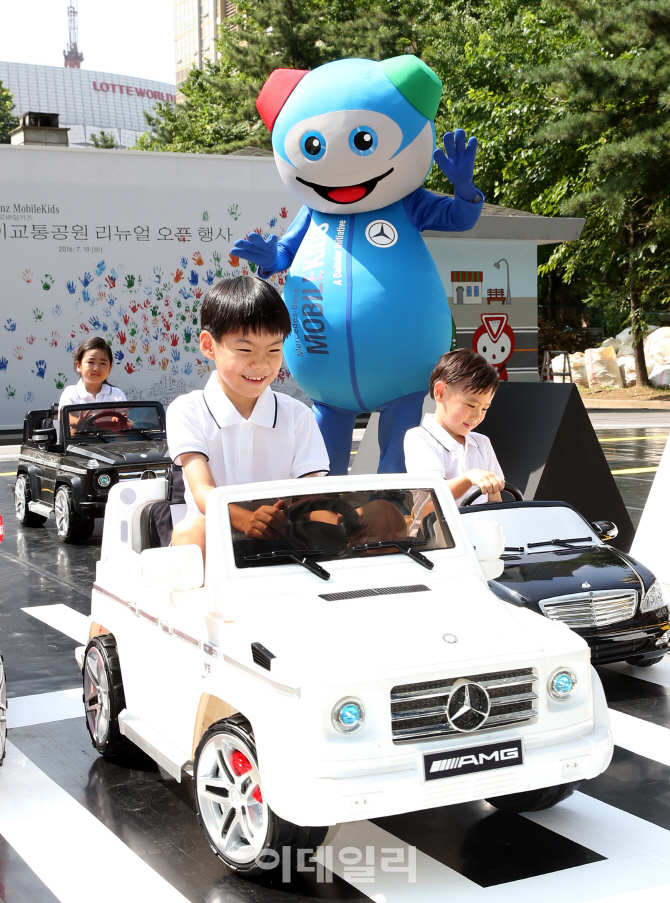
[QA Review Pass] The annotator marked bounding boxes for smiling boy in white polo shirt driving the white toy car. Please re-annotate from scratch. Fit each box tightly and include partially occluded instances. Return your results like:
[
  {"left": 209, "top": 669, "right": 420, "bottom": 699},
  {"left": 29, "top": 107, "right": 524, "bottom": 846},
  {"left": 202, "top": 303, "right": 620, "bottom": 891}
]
[{"left": 167, "top": 276, "right": 330, "bottom": 557}]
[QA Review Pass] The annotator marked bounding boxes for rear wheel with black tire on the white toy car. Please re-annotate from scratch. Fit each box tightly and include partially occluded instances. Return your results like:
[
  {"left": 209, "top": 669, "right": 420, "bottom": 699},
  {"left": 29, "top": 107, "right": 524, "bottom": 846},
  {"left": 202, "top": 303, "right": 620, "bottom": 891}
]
[{"left": 82, "top": 634, "right": 139, "bottom": 759}]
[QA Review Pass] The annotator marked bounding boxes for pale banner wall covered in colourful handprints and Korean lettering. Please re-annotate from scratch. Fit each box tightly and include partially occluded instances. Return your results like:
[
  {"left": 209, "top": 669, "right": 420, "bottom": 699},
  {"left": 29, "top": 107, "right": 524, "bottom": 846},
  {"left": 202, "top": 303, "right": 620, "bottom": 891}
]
[{"left": 0, "top": 149, "right": 300, "bottom": 429}]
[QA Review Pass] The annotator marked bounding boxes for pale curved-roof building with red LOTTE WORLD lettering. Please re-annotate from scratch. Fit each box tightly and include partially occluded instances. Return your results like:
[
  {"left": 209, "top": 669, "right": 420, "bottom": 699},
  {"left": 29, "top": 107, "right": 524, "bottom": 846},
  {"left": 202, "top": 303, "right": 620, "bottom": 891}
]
[{"left": 0, "top": 62, "right": 176, "bottom": 147}]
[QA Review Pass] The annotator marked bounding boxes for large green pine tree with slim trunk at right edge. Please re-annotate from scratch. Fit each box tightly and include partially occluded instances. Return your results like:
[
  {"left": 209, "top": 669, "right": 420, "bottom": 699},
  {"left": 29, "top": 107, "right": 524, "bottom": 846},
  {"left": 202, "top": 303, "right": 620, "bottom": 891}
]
[{"left": 530, "top": 0, "right": 670, "bottom": 384}]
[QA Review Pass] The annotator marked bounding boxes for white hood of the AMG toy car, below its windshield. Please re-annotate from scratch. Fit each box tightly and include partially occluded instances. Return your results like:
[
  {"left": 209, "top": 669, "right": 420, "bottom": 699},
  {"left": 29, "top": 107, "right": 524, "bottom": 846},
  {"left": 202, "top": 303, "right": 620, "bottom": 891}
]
[{"left": 218, "top": 584, "right": 585, "bottom": 680}]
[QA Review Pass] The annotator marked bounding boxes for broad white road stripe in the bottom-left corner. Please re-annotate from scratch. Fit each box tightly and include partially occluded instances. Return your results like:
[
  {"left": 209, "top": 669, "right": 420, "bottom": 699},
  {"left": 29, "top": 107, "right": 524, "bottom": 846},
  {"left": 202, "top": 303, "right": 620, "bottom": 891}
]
[{"left": 0, "top": 743, "right": 193, "bottom": 903}]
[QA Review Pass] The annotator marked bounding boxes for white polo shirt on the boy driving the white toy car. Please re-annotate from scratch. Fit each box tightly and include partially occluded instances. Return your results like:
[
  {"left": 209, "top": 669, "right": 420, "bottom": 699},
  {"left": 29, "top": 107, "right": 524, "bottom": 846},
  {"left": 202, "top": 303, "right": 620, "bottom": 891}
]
[{"left": 167, "top": 372, "right": 330, "bottom": 514}]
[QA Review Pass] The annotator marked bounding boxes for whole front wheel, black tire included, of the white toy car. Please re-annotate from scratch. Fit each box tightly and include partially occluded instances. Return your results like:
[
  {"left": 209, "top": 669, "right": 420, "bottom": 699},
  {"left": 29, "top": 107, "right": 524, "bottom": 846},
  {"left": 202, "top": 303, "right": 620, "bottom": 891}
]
[{"left": 193, "top": 715, "right": 328, "bottom": 878}]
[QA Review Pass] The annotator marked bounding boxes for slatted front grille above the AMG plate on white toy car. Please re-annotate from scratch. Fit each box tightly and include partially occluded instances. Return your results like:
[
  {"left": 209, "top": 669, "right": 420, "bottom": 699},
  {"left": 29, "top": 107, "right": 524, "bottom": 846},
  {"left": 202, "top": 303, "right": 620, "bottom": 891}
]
[{"left": 391, "top": 668, "right": 537, "bottom": 743}]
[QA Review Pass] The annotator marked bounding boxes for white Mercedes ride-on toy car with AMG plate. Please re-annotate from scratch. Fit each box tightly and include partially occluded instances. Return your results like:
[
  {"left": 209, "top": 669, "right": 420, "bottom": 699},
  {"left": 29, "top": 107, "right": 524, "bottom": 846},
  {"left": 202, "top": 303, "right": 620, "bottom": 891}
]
[{"left": 78, "top": 474, "right": 612, "bottom": 875}]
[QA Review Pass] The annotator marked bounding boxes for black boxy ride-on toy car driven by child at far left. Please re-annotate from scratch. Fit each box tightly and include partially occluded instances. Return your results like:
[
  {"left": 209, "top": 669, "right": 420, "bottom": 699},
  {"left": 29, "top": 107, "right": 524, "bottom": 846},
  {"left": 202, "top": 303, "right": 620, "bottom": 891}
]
[{"left": 14, "top": 401, "right": 171, "bottom": 543}]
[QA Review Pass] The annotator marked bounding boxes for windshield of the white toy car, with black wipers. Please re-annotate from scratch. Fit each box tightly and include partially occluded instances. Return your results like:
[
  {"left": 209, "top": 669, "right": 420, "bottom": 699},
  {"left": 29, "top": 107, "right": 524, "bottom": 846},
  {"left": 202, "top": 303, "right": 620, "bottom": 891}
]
[{"left": 229, "top": 489, "right": 454, "bottom": 576}]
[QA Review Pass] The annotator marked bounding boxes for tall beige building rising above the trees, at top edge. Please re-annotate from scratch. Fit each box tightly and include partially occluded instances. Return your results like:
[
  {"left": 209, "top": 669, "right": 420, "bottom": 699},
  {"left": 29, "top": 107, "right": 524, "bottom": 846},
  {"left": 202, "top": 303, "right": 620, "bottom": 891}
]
[{"left": 174, "top": 0, "right": 237, "bottom": 87}]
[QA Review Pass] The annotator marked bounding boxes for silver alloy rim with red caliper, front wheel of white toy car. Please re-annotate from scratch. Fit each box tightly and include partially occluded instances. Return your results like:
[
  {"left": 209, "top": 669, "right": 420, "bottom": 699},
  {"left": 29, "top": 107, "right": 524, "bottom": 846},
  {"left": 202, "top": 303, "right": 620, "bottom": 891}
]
[{"left": 195, "top": 731, "right": 269, "bottom": 865}]
